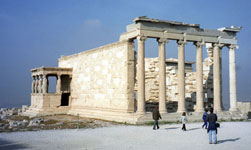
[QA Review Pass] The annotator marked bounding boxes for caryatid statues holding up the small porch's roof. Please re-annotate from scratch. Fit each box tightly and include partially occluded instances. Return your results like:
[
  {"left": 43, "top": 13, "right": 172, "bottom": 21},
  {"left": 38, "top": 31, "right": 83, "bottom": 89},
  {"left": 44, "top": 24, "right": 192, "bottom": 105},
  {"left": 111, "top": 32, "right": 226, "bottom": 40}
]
[{"left": 31, "top": 75, "right": 61, "bottom": 93}]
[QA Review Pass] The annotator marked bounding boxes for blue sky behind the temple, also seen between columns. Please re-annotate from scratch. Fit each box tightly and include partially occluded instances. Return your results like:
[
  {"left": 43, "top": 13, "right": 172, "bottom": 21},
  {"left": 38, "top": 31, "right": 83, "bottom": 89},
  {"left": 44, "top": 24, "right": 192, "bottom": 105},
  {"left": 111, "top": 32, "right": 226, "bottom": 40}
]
[{"left": 0, "top": 0, "right": 251, "bottom": 108}]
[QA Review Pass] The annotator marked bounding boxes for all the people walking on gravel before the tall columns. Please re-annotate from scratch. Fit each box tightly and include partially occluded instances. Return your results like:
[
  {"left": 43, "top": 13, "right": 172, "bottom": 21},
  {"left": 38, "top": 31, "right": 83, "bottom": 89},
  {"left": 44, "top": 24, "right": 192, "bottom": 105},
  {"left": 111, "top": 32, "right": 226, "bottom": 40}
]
[{"left": 152, "top": 107, "right": 219, "bottom": 144}]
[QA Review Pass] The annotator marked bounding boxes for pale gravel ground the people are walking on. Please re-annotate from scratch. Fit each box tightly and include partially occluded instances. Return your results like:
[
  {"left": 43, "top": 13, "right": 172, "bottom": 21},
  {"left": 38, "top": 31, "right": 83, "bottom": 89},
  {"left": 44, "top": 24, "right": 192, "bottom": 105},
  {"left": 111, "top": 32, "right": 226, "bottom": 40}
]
[{"left": 0, "top": 122, "right": 251, "bottom": 150}]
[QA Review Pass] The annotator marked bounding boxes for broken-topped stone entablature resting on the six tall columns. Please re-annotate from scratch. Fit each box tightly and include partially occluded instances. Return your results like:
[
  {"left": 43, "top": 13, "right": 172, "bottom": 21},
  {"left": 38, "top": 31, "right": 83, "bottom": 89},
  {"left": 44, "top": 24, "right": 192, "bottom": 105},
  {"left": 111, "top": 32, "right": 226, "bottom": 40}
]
[{"left": 120, "top": 17, "right": 241, "bottom": 45}]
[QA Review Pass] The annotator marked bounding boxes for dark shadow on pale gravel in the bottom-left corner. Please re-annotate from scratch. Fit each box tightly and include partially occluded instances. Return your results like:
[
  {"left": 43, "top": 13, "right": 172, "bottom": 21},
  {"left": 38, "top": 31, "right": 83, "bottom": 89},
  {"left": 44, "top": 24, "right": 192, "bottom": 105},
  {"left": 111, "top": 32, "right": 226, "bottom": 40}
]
[{"left": 0, "top": 138, "right": 31, "bottom": 150}]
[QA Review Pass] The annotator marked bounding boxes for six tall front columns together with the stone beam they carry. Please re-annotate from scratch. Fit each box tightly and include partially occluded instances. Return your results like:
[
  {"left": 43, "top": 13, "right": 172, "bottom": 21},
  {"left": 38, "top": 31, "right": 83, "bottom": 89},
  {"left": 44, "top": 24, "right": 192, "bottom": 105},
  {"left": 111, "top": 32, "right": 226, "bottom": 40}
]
[{"left": 120, "top": 17, "right": 241, "bottom": 114}]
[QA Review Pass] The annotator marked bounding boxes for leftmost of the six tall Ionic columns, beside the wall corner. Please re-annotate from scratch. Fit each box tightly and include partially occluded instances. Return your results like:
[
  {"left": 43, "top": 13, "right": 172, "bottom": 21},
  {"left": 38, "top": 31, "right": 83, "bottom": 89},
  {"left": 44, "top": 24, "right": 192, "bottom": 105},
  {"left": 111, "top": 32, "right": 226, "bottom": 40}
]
[{"left": 137, "top": 36, "right": 146, "bottom": 114}]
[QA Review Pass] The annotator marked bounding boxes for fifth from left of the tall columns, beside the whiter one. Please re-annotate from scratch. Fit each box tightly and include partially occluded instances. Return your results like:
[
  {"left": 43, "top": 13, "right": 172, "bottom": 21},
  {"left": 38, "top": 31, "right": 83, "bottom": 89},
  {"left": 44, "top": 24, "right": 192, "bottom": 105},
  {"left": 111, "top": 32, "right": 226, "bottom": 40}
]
[{"left": 213, "top": 44, "right": 223, "bottom": 112}]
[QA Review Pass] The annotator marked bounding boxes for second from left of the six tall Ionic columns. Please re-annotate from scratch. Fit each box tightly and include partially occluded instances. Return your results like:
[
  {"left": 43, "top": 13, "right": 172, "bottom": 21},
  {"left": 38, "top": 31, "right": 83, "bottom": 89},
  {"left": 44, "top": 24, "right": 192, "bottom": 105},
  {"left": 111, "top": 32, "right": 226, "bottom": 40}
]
[{"left": 157, "top": 39, "right": 167, "bottom": 113}]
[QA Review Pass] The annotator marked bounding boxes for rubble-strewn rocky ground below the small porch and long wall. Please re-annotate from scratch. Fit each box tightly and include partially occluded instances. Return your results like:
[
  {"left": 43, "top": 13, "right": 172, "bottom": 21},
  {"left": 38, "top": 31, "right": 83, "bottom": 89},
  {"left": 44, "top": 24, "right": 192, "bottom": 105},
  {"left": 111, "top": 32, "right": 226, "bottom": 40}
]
[{"left": 0, "top": 108, "right": 116, "bottom": 132}]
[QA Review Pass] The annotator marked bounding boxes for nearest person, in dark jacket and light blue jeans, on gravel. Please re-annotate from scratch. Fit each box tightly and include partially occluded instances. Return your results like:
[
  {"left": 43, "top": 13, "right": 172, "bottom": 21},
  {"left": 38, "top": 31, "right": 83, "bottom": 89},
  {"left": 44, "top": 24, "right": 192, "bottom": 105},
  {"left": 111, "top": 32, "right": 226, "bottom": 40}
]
[{"left": 207, "top": 108, "right": 217, "bottom": 144}]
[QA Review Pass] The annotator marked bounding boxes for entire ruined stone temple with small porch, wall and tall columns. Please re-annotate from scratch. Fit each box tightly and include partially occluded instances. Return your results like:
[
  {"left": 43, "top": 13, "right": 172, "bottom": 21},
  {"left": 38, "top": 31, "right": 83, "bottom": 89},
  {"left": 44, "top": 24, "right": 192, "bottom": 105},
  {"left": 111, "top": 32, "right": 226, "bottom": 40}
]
[{"left": 25, "top": 17, "right": 245, "bottom": 123}]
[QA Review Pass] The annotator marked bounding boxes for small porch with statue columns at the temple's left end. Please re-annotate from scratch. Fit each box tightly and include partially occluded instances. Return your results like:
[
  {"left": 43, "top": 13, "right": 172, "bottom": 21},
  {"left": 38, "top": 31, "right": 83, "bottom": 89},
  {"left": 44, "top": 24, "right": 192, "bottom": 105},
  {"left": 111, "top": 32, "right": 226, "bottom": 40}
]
[{"left": 30, "top": 67, "right": 72, "bottom": 111}]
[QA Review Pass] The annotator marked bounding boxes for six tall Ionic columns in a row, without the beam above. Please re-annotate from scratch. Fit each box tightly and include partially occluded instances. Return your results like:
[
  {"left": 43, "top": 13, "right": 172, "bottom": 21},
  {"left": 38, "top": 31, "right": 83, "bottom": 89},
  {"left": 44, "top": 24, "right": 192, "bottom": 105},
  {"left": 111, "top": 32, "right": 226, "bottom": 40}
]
[{"left": 137, "top": 36, "right": 237, "bottom": 114}]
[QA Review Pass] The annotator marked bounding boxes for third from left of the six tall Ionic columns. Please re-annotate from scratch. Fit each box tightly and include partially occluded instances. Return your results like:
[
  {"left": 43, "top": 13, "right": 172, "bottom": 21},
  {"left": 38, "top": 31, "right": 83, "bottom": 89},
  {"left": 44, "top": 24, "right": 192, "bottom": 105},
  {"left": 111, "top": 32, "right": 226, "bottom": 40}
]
[{"left": 177, "top": 40, "right": 186, "bottom": 113}]
